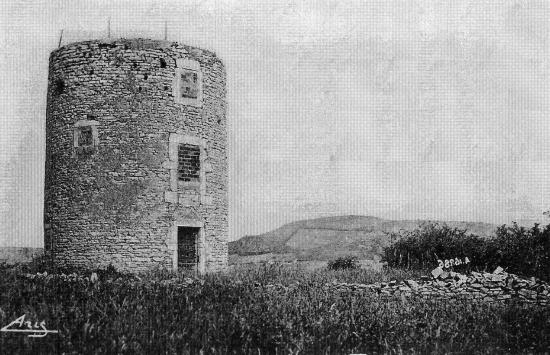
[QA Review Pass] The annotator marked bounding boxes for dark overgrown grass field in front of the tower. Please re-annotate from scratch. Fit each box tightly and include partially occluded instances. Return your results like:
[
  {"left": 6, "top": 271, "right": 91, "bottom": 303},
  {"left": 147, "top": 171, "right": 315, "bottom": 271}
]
[{"left": 0, "top": 265, "right": 550, "bottom": 354}]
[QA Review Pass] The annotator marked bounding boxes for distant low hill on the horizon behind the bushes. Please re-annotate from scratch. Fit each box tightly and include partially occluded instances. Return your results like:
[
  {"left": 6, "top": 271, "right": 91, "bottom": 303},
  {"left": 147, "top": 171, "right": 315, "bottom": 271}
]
[{"left": 229, "top": 216, "right": 497, "bottom": 260}]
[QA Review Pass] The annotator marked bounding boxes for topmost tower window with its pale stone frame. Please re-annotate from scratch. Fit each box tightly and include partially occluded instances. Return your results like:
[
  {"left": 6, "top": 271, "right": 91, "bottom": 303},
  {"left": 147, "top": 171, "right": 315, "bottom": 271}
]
[{"left": 173, "top": 59, "right": 202, "bottom": 106}]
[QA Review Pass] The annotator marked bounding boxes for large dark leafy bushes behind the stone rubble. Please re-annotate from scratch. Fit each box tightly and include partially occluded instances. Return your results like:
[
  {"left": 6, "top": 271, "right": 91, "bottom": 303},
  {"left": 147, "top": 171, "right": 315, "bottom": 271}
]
[{"left": 384, "top": 223, "right": 550, "bottom": 280}]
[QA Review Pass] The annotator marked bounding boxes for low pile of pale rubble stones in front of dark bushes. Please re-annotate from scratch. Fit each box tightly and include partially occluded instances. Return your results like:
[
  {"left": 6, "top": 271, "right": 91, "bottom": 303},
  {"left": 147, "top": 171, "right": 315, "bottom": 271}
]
[{"left": 332, "top": 267, "right": 550, "bottom": 305}]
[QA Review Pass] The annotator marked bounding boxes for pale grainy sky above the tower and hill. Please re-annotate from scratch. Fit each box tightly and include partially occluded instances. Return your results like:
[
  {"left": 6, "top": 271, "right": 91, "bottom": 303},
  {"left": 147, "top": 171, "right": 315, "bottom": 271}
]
[{"left": 0, "top": 0, "right": 550, "bottom": 245}]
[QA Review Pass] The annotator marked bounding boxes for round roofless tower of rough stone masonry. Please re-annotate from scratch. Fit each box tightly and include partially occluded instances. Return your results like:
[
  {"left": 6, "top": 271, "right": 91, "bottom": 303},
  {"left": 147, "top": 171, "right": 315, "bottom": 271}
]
[{"left": 44, "top": 39, "right": 228, "bottom": 272}]
